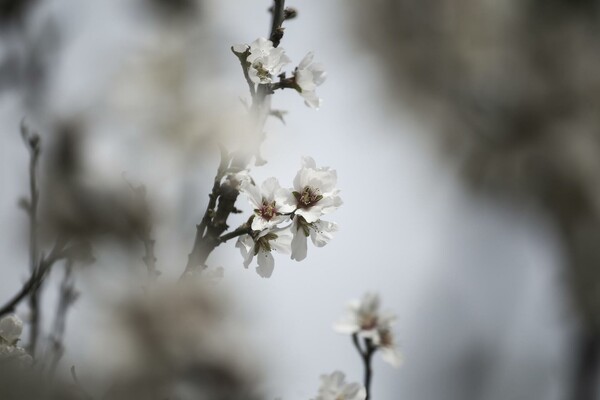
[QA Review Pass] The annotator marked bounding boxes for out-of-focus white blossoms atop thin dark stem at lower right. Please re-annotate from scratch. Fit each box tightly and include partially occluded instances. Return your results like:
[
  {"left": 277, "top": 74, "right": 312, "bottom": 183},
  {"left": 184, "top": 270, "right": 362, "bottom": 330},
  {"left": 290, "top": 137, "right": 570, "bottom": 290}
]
[{"left": 334, "top": 293, "right": 402, "bottom": 367}]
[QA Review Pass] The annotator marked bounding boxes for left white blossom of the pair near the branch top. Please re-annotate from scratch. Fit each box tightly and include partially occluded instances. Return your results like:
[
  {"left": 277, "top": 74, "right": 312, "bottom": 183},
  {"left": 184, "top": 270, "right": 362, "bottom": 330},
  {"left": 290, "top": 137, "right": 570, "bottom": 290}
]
[{"left": 245, "top": 37, "right": 290, "bottom": 84}]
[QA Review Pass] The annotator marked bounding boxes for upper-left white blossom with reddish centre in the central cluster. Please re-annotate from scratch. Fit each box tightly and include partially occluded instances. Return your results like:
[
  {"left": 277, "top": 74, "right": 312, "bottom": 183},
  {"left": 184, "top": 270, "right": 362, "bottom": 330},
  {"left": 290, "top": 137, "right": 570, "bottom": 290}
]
[{"left": 240, "top": 178, "right": 294, "bottom": 231}]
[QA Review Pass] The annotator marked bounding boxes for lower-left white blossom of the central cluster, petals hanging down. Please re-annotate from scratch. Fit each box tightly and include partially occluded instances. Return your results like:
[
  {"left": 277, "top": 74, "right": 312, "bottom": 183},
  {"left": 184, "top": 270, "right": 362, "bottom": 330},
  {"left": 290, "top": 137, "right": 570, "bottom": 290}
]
[{"left": 235, "top": 229, "right": 292, "bottom": 278}]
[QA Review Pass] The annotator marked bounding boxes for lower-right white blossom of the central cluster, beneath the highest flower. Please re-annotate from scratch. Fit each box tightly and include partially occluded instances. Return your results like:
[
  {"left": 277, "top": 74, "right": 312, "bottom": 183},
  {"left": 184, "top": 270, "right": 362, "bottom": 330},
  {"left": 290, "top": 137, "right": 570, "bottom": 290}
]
[{"left": 292, "top": 215, "right": 338, "bottom": 261}]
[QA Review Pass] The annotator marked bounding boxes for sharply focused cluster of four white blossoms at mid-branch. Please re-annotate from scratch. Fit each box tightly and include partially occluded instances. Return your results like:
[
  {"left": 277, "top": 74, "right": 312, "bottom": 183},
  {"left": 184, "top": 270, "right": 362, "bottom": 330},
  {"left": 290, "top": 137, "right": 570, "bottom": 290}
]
[{"left": 236, "top": 157, "right": 342, "bottom": 278}]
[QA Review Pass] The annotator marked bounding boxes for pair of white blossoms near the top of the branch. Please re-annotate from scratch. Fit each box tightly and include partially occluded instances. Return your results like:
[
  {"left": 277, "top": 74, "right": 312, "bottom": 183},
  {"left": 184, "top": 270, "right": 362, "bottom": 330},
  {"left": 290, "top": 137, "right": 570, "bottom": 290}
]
[{"left": 232, "top": 37, "right": 326, "bottom": 109}]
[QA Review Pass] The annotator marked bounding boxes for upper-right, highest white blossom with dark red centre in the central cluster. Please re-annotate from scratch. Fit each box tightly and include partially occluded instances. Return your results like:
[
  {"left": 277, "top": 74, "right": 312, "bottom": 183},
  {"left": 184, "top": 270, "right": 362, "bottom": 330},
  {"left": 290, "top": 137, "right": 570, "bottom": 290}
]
[{"left": 286, "top": 157, "right": 343, "bottom": 223}]
